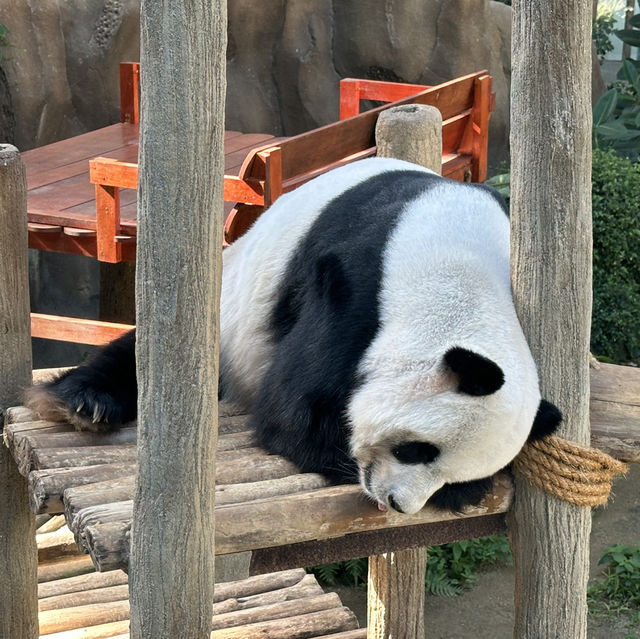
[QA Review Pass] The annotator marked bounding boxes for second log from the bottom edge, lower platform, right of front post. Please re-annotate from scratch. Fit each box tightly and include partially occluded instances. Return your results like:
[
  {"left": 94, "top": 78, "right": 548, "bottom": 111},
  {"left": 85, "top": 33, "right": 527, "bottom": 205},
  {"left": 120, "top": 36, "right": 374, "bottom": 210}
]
[{"left": 211, "top": 607, "right": 358, "bottom": 639}]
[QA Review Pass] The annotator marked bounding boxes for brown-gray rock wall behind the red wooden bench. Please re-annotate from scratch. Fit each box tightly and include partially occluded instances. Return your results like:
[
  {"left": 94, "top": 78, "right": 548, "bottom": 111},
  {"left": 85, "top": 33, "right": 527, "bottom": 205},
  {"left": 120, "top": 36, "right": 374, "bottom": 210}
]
[{"left": 0, "top": 0, "right": 511, "bottom": 165}]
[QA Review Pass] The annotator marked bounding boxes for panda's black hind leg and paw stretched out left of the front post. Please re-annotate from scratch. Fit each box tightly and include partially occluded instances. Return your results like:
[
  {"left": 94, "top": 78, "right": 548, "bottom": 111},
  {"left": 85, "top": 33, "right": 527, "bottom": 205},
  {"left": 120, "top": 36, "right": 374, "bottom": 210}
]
[{"left": 25, "top": 330, "right": 138, "bottom": 431}]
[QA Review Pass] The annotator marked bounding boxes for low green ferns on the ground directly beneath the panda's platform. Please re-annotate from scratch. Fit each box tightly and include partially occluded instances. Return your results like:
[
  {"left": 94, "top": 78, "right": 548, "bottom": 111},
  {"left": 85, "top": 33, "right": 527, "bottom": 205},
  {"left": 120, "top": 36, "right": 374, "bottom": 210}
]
[{"left": 308, "top": 535, "right": 511, "bottom": 597}]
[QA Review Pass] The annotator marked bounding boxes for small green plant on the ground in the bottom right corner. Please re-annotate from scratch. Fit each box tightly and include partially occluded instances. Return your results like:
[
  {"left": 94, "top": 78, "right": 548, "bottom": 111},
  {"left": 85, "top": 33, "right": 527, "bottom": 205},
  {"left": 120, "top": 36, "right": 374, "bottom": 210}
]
[{"left": 587, "top": 542, "right": 640, "bottom": 639}]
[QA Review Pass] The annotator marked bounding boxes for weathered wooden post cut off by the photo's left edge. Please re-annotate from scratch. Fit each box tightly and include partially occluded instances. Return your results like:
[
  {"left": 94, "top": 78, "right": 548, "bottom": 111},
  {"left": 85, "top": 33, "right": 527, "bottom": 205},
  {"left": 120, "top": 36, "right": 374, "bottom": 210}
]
[{"left": 0, "top": 144, "right": 38, "bottom": 639}]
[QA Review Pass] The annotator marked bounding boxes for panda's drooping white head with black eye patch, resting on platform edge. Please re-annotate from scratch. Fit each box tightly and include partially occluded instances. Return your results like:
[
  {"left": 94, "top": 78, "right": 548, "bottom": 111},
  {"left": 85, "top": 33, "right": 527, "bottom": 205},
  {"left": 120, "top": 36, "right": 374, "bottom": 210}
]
[{"left": 348, "top": 347, "right": 540, "bottom": 514}]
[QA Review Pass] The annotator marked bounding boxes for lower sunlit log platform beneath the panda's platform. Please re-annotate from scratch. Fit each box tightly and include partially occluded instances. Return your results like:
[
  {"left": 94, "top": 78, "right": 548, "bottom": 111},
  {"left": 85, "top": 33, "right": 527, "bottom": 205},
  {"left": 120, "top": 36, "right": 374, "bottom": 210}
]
[{"left": 38, "top": 569, "right": 367, "bottom": 639}]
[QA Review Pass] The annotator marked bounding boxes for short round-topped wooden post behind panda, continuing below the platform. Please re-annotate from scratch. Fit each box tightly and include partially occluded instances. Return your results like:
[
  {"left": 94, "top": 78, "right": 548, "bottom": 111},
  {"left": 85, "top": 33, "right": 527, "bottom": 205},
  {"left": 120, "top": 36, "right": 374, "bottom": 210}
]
[{"left": 367, "top": 104, "right": 442, "bottom": 639}]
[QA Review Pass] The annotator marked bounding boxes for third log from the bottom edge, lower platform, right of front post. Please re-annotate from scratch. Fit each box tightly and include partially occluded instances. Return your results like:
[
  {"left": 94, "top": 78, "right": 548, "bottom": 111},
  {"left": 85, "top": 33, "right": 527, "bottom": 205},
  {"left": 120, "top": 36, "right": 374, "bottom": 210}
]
[{"left": 211, "top": 592, "right": 342, "bottom": 630}]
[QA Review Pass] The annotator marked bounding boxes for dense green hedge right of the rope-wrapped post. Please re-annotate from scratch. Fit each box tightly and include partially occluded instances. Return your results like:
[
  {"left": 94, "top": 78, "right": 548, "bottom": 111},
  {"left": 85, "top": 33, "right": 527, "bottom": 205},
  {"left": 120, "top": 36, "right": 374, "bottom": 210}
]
[{"left": 591, "top": 149, "right": 640, "bottom": 362}]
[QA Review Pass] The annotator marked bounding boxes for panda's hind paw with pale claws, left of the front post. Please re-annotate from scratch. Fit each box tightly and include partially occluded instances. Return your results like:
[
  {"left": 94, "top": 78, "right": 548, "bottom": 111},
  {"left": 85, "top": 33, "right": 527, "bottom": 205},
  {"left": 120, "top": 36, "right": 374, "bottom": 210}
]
[{"left": 25, "top": 367, "right": 137, "bottom": 432}]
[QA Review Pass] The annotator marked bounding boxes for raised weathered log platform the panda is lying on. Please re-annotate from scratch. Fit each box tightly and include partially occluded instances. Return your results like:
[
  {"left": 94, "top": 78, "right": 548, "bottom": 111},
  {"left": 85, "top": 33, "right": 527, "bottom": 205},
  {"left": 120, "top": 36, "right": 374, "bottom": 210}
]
[{"left": 4, "top": 364, "right": 640, "bottom": 574}]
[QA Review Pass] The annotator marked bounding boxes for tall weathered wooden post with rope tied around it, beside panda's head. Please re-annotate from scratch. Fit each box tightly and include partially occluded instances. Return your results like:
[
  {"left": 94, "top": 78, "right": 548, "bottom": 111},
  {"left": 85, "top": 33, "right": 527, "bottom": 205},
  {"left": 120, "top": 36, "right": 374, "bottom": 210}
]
[{"left": 509, "top": 0, "right": 591, "bottom": 639}]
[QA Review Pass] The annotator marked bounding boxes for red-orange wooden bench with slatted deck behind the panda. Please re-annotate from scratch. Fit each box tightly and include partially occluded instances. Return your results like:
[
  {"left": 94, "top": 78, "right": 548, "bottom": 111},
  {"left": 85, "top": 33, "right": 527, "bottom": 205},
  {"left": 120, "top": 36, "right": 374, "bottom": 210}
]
[{"left": 23, "top": 63, "right": 495, "bottom": 344}]
